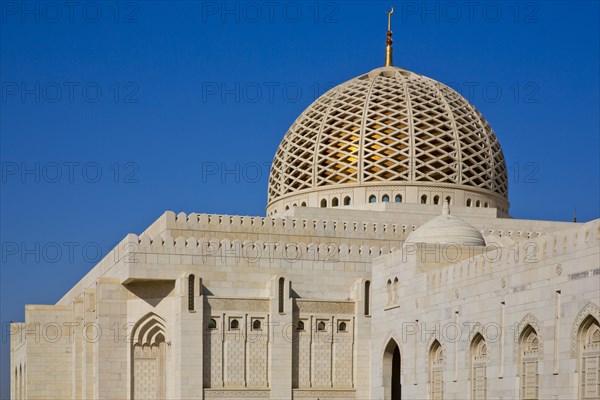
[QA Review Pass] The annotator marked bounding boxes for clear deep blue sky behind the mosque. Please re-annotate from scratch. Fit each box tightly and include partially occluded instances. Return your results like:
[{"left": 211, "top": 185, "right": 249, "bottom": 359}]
[{"left": 0, "top": 1, "right": 600, "bottom": 398}]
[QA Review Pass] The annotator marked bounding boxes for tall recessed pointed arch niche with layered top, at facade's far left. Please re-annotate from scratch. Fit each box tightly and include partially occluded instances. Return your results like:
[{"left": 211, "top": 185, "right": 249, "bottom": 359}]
[{"left": 131, "top": 313, "right": 167, "bottom": 399}]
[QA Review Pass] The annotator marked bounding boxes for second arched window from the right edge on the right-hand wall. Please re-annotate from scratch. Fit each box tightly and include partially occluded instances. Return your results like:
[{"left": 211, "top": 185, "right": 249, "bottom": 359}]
[{"left": 519, "top": 325, "right": 540, "bottom": 400}]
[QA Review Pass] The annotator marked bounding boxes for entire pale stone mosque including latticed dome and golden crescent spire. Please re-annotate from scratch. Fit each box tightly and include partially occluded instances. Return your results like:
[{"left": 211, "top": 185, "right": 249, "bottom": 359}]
[{"left": 10, "top": 9, "right": 600, "bottom": 400}]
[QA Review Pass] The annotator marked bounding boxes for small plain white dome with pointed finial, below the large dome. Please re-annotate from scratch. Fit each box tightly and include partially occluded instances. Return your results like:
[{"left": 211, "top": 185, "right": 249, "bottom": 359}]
[{"left": 406, "top": 203, "right": 485, "bottom": 246}]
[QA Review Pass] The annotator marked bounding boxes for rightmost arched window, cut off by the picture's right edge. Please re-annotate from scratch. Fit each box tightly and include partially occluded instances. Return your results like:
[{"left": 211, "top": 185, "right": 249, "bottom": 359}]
[{"left": 577, "top": 315, "right": 600, "bottom": 400}]
